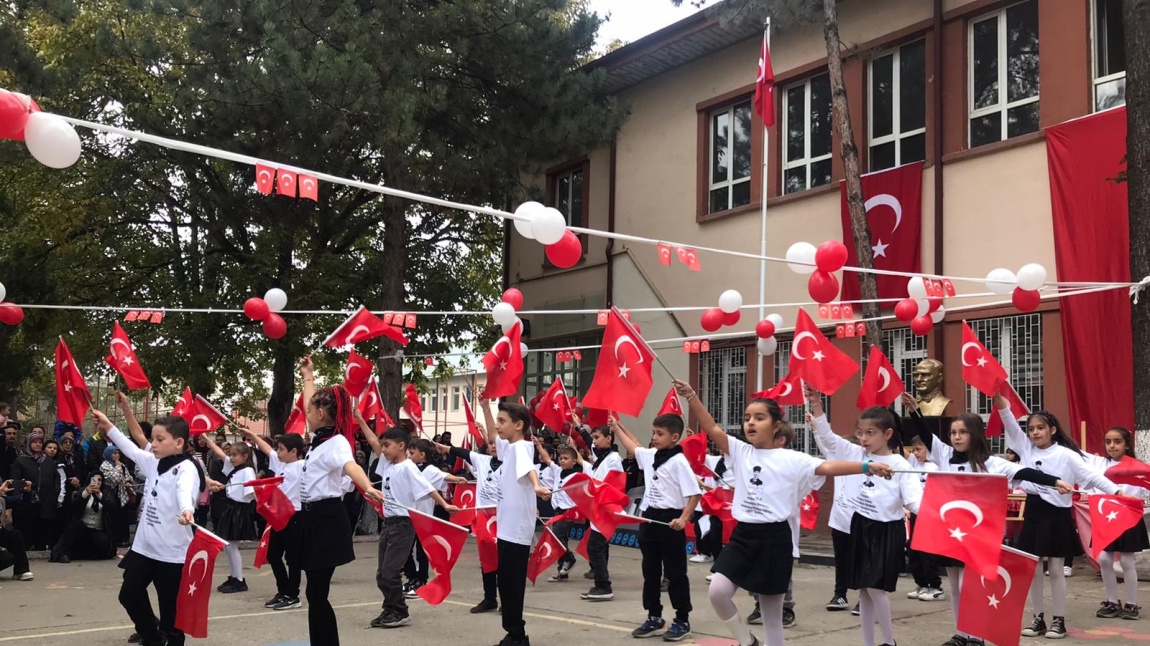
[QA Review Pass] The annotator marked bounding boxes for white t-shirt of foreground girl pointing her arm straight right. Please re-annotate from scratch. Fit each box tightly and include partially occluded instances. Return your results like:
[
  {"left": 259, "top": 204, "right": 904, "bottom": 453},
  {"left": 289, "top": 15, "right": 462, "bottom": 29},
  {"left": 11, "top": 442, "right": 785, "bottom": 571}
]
[{"left": 727, "top": 437, "right": 823, "bottom": 523}]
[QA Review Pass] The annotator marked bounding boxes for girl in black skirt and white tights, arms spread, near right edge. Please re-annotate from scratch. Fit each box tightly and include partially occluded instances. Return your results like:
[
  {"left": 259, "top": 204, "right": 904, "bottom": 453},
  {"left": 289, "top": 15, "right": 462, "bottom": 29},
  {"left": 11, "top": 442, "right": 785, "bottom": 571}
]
[{"left": 995, "top": 393, "right": 1118, "bottom": 639}]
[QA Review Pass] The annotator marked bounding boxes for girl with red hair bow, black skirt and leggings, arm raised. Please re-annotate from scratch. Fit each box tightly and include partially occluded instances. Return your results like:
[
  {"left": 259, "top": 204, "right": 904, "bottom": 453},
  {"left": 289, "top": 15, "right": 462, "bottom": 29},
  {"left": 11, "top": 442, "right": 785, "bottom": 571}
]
[{"left": 299, "top": 356, "right": 383, "bottom": 646}]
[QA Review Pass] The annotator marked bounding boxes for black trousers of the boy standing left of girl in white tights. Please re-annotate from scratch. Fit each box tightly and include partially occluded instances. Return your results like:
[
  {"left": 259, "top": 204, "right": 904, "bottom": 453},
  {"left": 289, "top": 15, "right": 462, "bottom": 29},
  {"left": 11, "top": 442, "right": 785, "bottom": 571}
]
[{"left": 639, "top": 509, "right": 691, "bottom": 623}]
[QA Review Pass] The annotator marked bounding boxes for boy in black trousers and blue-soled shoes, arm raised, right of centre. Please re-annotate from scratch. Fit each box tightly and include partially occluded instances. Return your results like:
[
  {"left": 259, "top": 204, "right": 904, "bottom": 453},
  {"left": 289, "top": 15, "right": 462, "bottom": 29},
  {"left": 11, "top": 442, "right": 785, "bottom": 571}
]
[{"left": 607, "top": 415, "right": 703, "bottom": 641}]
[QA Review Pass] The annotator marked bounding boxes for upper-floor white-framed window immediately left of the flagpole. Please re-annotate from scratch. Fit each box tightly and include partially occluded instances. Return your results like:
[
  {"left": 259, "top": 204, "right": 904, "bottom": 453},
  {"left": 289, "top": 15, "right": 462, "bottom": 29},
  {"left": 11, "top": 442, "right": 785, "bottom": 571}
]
[{"left": 707, "top": 101, "right": 751, "bottom": 213}]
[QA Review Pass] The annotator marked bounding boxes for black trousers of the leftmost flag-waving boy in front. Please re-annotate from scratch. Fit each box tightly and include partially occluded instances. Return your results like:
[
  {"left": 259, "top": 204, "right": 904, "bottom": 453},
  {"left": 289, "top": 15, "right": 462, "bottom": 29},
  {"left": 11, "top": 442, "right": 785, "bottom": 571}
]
[{"left": 120, "top": 552, "right": 184, "bottom": 646}]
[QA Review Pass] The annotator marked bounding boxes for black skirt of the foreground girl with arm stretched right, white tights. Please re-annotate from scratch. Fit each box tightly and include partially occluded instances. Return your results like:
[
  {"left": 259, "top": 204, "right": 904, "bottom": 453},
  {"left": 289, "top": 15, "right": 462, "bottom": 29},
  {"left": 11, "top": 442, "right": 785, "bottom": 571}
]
[{"left": 711, "top": 522, "right": 795, "bottom": 594}]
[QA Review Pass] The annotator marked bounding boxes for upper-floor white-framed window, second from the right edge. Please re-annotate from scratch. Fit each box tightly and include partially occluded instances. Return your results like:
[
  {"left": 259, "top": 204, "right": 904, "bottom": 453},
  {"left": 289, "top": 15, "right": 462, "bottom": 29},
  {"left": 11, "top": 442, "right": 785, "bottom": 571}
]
[{"left": 969, "top": 0, "right": 1038, "bottom": 148}]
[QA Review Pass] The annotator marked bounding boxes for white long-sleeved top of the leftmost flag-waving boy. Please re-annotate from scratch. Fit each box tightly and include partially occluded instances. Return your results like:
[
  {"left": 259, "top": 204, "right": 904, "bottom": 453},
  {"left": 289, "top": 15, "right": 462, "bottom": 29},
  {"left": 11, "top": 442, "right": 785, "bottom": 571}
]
[{"left": 105, "top": 426, "right": 200, "bottom": 563}]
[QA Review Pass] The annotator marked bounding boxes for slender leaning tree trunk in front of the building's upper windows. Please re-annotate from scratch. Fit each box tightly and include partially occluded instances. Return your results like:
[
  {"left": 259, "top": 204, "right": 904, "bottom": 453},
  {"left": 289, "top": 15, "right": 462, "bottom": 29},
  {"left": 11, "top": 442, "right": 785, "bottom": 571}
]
[{"left": 822, "top": 0, "right": 882, "bottom": 346}]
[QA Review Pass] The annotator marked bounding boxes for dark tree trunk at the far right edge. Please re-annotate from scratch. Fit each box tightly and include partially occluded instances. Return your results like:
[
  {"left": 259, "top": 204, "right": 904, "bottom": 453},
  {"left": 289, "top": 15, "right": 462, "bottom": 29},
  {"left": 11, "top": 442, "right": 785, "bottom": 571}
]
[{"left": 1122, "top": 0, "right": 1150, "bottom": 459}]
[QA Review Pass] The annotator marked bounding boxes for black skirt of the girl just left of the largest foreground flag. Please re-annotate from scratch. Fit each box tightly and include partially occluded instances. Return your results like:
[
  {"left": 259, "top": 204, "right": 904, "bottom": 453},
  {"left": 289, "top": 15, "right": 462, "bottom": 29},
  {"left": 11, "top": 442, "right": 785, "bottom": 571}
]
[{"left": 846, "top": 513, "right": 906, "bottom": 592}]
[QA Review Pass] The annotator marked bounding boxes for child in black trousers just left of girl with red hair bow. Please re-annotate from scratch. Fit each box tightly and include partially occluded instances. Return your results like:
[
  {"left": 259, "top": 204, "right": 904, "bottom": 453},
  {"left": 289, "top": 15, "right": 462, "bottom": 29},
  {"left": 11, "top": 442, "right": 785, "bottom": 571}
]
[{"left": 244, "top": 429, "right": 304, "bottom": 610}]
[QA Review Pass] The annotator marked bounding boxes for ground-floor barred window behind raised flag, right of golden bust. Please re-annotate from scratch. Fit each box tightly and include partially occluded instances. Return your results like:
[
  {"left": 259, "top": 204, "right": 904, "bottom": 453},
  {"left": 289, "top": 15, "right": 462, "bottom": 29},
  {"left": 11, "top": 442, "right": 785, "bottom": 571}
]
[{"left": 966, "top": 314, "right": 1044, "bottom": 453}]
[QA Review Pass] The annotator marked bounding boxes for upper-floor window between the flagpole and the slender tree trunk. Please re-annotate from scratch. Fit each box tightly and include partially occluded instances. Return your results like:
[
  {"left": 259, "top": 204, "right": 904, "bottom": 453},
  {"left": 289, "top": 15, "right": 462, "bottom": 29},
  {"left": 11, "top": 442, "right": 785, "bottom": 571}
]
[{"left": 783, "top": 74, "right": 831, "bottom": 193}]
